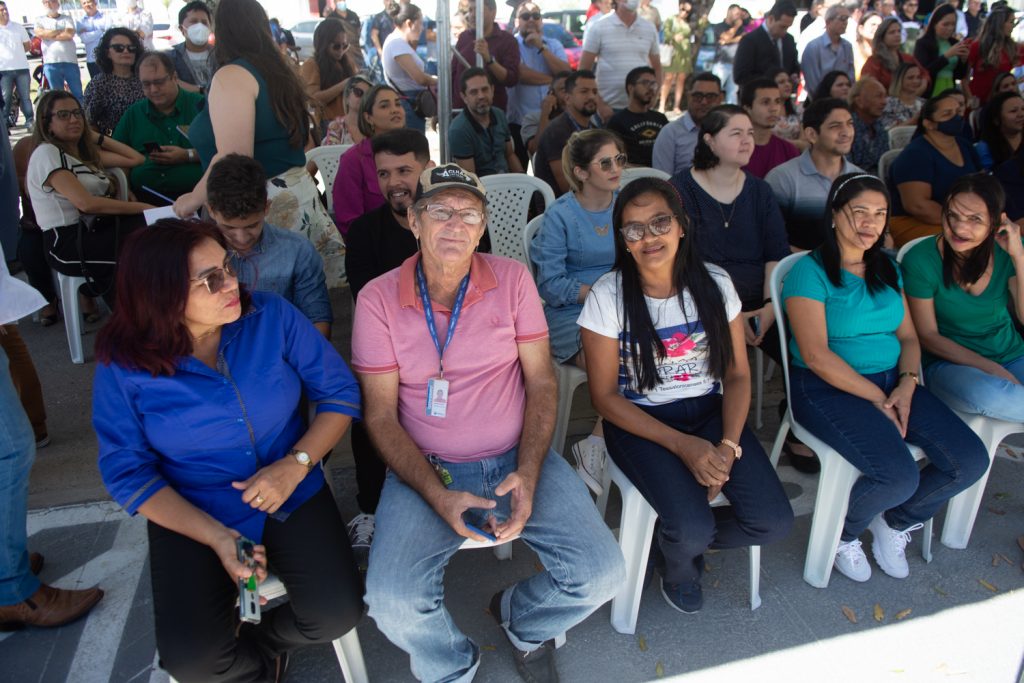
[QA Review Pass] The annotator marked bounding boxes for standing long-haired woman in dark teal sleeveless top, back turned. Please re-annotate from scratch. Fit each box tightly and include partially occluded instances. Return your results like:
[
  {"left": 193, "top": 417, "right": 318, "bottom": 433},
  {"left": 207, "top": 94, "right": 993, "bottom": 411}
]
[{"left": 174, "top": 0, "right": 345, "bottom": 287}]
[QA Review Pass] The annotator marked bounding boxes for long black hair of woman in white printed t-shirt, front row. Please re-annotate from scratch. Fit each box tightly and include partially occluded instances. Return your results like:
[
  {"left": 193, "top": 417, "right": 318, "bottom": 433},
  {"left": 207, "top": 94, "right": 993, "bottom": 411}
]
[{"left": 611, "top": 177, "right": 733, "bottom": 391}]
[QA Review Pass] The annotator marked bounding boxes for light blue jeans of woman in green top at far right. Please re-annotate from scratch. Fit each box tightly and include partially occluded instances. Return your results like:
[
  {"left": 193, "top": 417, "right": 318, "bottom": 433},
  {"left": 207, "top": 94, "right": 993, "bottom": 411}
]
[{"left": 925, "top": 356, "right": 1024, "bottom": 422}]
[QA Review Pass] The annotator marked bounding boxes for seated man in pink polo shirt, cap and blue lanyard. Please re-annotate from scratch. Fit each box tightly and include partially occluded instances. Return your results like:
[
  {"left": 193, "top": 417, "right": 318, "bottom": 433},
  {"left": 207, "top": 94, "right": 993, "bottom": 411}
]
[{"left": 352, "top": 164, "right": 625, "bottom": 681}]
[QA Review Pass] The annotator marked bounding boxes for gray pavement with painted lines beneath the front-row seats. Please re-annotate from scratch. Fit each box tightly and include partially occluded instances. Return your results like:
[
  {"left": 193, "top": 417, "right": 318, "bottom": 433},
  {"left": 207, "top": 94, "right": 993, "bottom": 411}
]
[{"left": 0, "top": 274, "right": 1024, "bottom": 683}]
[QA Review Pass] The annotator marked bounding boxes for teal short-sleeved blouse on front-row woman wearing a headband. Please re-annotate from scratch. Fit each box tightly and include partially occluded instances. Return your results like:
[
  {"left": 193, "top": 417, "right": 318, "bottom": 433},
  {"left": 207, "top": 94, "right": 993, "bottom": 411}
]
[{"left": 782, "top": 252, "right": 903, "bottom": 375}]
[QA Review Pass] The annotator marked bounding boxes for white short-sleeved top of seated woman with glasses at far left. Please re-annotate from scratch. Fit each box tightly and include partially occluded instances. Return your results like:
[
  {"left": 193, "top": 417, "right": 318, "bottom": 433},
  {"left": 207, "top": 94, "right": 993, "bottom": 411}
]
[{"left": 26, "top": 142, "right": 111, "bottom": 230}]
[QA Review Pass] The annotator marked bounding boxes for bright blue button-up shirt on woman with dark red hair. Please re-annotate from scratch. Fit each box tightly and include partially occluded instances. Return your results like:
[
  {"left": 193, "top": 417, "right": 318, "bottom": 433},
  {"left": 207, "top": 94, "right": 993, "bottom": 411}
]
[{"left": 92, "top": 292, "right": 360, "bottom": 542}]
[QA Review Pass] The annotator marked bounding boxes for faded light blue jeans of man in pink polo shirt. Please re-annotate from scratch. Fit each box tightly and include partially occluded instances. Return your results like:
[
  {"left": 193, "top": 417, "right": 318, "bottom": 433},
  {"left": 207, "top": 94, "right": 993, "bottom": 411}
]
[{"left": 366, "top": 449, "right": 626, "bottom": 681}]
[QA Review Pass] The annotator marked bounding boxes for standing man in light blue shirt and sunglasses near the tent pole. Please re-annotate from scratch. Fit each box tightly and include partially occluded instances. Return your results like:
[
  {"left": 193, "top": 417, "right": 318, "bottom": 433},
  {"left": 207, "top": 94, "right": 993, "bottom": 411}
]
[{"left": 508, "top": 2, "right": 571, "bottom": 168}]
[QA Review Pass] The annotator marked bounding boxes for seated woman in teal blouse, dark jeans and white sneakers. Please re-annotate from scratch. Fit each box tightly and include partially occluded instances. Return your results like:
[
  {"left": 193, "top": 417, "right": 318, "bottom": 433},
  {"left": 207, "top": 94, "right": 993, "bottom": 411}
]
[{"left": 782, "top": 173, "right": 989, "bottom": 582}]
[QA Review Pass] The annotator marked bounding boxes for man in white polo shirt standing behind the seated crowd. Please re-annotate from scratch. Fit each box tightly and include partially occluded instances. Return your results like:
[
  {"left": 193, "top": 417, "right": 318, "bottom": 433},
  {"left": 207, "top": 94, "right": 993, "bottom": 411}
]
[{"left": 580, "top": 0, "right": 662, "bottom": 114}]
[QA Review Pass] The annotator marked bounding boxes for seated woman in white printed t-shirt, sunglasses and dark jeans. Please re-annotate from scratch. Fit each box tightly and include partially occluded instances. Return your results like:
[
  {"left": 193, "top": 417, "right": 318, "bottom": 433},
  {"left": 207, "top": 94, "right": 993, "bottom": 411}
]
[{"left": 579, "top": 178, "right": 793, "bottom": 613}]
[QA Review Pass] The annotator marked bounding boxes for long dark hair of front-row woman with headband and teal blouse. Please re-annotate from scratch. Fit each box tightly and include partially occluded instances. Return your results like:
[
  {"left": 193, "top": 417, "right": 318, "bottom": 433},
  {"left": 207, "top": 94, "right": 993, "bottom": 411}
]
[{"left": 813, "top": 173, "right": 900, "bottom": 294}]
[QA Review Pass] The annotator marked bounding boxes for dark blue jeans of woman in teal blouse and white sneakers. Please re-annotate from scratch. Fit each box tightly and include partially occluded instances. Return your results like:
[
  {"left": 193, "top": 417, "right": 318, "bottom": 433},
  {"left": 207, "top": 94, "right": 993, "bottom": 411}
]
[{"left": 790, "top": 366, "right": 989, "bottom": 542}]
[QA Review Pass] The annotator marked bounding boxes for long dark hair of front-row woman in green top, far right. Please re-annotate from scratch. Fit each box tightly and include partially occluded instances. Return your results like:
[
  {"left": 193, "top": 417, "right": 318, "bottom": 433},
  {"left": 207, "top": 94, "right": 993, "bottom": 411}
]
[{"left": 940, "top": 173, "right": 1007, "bottom": 287}]
